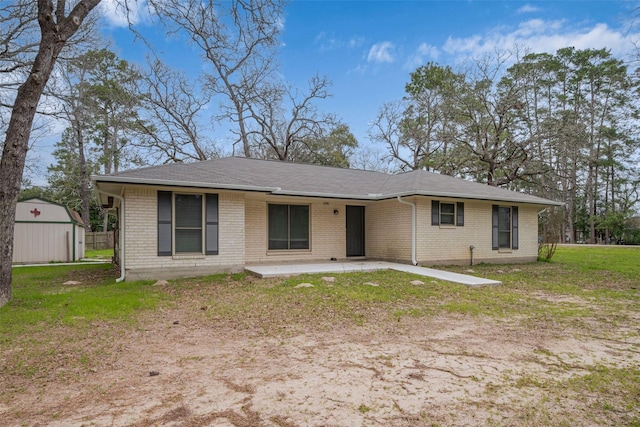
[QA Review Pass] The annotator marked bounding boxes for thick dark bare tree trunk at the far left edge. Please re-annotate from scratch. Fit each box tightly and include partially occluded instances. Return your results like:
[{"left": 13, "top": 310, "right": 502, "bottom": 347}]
[{"left": 0, "top": 0, "right": 100, "bottom": 306}]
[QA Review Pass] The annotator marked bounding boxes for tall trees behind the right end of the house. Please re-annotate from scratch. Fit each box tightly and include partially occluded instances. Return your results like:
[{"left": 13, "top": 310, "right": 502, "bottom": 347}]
[{"left": 370, "top": 47, "right": 640, "bottom": 243}]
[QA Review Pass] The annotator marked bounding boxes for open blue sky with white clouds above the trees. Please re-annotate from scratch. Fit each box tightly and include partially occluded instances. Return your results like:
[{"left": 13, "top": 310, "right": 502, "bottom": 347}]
[{"left": 28, "top": 0, "right": 640, "bottom": 179}]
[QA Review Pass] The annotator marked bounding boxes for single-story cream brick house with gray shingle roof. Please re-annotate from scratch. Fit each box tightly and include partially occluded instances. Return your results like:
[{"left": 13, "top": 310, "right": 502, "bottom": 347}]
[{"left": 93, "top": 157, "right": 559, "bottom": 279}]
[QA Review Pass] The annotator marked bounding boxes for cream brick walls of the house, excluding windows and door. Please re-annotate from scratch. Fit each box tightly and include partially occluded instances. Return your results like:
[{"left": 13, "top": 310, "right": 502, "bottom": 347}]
[{"left": 124, "top": 186, "right": 538, "bottom": 279}]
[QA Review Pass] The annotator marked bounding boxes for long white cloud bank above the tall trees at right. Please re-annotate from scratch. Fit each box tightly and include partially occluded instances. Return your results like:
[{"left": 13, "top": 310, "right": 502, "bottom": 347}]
[{"left": 442, "top": 19, "right": 637, "bottom": 59}]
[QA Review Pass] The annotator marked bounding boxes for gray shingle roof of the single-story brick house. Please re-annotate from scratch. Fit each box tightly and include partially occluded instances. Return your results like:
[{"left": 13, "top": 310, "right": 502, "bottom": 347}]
[{"left": 93, "top": 157, "right": 559, "bottom": 205}]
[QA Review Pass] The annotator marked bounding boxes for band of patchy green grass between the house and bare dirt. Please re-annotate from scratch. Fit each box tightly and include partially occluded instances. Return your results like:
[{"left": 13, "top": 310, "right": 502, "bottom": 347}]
[{"left": 6, "top": 247, "right": 640, "bottom": 334}]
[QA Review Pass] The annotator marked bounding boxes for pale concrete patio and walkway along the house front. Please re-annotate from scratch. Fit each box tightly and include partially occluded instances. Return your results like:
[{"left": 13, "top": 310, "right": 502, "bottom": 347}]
[{"left": 245, "top": 261, "right": 502, "bottom": 286}]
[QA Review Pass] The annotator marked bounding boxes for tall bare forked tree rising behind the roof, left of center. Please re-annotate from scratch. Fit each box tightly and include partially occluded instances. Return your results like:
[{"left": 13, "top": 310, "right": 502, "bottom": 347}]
[{"left": 149, "top": 0, "right": 283, "bottom": 157}]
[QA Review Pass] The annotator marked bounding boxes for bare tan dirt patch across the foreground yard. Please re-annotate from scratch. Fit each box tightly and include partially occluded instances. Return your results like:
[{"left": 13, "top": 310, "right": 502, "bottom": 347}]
[{"left": 5, "top": 302, "right": 640, "bottom": 427}]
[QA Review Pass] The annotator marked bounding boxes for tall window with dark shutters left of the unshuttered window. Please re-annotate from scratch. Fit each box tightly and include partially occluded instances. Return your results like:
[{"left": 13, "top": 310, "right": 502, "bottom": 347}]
[{"left": 158, "top": 191, "right": 218, "bottom": 256}]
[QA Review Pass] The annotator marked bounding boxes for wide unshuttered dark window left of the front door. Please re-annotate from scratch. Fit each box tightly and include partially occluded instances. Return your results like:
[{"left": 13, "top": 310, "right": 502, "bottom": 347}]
[{"left": 269, "top": 204, "right": 309, "bottom": 250}]
